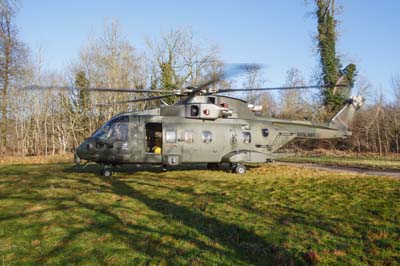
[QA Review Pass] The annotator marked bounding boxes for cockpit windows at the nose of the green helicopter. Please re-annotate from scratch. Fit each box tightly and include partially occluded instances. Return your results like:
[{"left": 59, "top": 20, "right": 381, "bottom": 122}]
[{"left": 92, "top": 116, "right": 129, "bottom": 141}]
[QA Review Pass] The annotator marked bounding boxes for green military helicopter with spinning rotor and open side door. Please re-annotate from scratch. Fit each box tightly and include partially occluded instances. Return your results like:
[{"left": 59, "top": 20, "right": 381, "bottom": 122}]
[{"left": 58, "top": 66, "right": 365, "bottom": 177}]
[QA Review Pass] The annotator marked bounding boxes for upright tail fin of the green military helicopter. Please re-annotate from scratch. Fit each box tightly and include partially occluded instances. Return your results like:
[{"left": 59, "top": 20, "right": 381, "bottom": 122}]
[{"left": 329, "top": 95, "right": 365, "bottom": 132}]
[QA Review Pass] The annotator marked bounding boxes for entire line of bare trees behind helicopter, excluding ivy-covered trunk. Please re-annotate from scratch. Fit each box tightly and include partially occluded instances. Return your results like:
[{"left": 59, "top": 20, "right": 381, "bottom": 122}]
[{"left": 0, "top": 0, "right": 400, "bottom": 155}]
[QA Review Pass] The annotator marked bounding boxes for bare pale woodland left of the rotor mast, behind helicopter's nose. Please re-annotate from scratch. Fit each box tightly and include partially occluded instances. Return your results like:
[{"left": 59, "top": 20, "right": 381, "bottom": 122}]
[{"left": 0, "top": 0, "right": 223, "bottom": 155}]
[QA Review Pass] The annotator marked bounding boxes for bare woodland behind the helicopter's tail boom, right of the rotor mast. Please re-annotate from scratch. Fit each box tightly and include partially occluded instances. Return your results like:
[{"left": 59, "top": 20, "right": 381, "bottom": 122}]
[{"left": 253, "top": 69, "right": 400, "bottom": 155}]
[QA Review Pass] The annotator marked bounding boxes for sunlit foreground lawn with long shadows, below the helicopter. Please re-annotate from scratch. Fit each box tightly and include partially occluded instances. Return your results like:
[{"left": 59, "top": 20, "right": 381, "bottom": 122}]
[{"left": 0, "top": 164, "right": 400, "bottom": 265}]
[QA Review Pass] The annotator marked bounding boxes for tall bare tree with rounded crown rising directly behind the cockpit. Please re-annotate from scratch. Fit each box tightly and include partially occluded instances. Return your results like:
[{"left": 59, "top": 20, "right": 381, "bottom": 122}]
[{"left": 72, "top": 20, "right": 147, "bottom": 128}]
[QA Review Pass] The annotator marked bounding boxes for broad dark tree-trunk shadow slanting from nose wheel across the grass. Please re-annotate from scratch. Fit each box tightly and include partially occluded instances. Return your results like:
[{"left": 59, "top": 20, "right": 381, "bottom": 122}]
[{"left": 107, "top": 176, "right": 303, "bottom": 265}]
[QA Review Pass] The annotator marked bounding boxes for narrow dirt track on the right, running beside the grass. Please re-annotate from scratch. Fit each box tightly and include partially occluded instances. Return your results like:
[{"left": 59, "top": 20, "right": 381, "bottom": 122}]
[{"left": 277, "top": 162, "right": 400, "bottom": 178}]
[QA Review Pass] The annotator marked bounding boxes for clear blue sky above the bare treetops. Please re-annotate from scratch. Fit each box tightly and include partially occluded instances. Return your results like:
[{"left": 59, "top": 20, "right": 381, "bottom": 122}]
[{"left": 17, "top": 0, "right": 400, "bottom": 97}]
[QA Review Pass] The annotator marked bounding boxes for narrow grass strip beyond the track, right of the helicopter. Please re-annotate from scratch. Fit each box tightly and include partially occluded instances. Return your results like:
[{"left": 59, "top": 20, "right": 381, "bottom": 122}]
[{"left": 281, "top": 156, "right": 400, "bottom": 170}]
